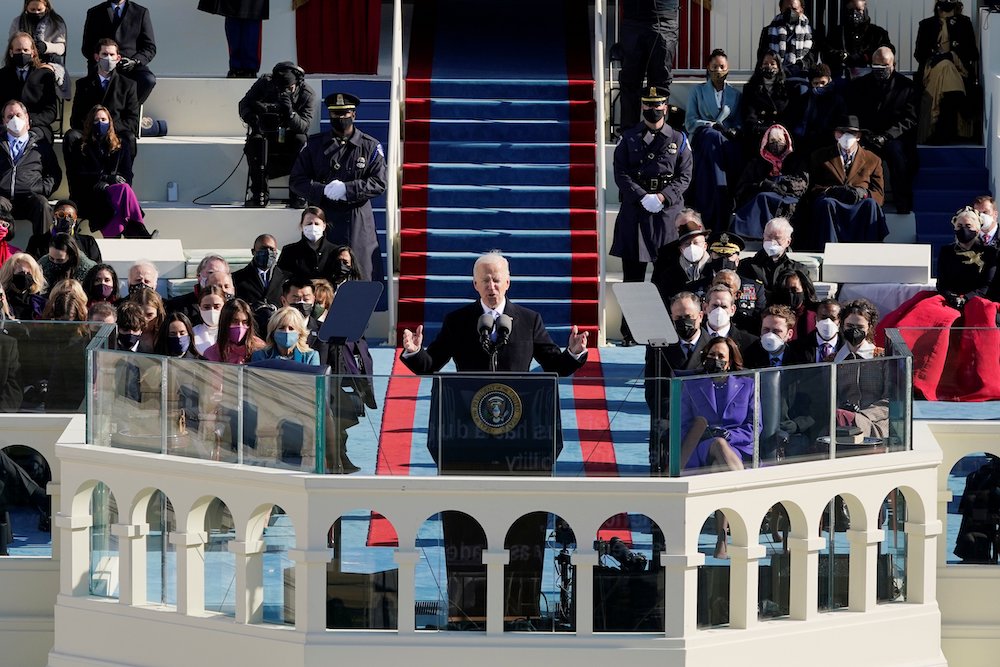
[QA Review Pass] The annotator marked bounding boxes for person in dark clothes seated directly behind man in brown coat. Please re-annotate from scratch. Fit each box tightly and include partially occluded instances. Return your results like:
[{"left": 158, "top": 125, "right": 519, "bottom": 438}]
[{"left": 786, "top": 64, "right": 847, "bottom": 159}]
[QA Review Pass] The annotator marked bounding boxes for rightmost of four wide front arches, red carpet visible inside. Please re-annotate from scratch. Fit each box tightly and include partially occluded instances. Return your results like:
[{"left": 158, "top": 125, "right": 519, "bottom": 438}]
[{"left": 594, "top": 514, "right": 666, "bottom": 632}]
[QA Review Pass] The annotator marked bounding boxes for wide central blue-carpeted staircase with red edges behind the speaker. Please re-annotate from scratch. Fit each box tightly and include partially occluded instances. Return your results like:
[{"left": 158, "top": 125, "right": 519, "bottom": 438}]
[{"left": 399, "top": 0, "right": 599, "bottom": 344}]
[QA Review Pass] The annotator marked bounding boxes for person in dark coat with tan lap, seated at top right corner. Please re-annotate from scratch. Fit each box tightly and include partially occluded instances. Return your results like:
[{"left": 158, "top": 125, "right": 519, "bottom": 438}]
[{"left": 913, "top": 0, "right": 981, "bottom": 144}]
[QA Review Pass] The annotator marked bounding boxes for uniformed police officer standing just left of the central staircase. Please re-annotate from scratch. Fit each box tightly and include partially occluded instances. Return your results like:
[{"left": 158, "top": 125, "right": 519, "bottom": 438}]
[{"left": 288, "top": 93, "right": 386, "bottom": 281}]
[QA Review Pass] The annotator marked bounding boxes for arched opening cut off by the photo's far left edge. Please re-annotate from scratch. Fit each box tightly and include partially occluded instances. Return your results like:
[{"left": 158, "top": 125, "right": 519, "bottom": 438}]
[{"left": 0, "top": 445, "right": 52, "bottom": 557}]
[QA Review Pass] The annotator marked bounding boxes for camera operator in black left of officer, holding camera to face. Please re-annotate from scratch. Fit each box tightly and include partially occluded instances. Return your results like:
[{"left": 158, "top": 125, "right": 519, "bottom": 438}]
[{"left": 240, "top": 61, "right": 316, "bottom": 208}]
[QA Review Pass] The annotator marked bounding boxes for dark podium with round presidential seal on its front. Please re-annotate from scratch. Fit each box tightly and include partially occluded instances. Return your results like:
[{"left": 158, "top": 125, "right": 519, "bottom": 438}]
[{"left": 427, "top": 372, "right": 562, "bottom": 475}]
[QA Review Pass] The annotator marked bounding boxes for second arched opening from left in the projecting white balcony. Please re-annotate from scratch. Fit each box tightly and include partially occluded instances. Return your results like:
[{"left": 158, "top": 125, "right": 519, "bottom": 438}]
[{"left": 136, "top": 489, "right": 177, "bottom": 607}]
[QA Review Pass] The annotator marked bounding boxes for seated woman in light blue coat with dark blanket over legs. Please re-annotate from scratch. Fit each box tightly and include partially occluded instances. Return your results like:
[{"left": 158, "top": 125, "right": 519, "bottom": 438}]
[{"left": 685, "top": 49, "right": 742, "bottom": 231}]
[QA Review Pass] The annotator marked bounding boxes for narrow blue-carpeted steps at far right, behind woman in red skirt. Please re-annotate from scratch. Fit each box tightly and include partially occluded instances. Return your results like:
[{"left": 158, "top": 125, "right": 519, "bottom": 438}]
[{"left": 913, "top": 146, "right": 989, "bottom": 275}]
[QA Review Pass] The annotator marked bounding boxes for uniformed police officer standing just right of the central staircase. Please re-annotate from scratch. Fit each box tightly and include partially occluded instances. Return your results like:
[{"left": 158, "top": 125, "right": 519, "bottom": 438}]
[{"left": 611, "top": 86, "right": 691, "bottom": 346}]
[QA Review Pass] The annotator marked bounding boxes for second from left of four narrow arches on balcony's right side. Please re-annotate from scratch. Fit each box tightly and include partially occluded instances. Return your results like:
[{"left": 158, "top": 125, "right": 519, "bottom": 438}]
[{"left": 757, "top": 503, "right": 792, "bottom": 619}]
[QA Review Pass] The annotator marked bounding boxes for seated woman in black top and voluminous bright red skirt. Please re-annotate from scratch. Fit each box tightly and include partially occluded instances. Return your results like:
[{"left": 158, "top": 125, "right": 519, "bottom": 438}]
[{"left": 875, "top": 206, "right": 1000, "bottom": 401}]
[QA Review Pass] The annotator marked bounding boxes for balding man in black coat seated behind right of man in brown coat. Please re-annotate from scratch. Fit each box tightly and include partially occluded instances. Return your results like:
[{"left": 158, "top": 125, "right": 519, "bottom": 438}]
[{"left": 847, "top": 46, "right": 920, "bottom": 213}]
